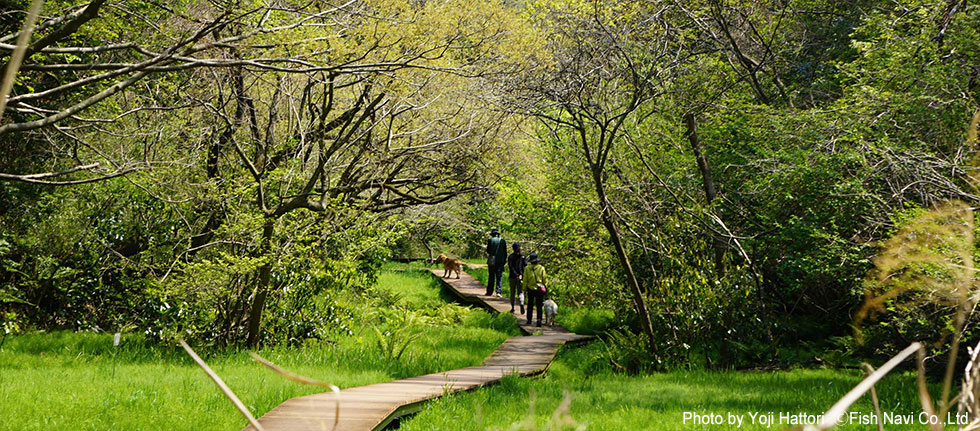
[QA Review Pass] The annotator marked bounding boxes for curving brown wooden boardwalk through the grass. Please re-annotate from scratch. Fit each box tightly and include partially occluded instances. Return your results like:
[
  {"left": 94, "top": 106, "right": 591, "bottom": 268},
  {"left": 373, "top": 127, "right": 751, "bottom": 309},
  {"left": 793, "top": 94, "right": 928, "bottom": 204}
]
[{"left": 245, "top": 270, "right": 591, "bottom": 431}]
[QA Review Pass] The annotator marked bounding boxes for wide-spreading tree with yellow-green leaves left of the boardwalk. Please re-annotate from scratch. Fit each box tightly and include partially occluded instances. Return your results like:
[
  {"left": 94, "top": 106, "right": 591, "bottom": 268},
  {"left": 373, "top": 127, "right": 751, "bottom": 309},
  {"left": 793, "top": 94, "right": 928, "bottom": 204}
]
[{"left": 190, "top": 0, "right": 524, "bottom": 345}]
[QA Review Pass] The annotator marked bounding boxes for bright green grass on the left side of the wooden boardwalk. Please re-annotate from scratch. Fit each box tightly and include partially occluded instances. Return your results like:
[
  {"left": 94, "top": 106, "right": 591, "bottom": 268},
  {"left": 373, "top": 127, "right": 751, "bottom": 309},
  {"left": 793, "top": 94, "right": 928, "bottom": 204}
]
[{"left": 0, "top": 272, "right": 518, "bottom": 431}]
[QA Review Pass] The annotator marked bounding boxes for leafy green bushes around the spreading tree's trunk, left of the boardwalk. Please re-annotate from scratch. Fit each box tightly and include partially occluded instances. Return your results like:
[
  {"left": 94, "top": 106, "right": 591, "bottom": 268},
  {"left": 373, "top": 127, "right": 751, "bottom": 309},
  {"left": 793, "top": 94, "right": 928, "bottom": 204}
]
[{"left": 153, "top": 213, "right": 397, "bottom": 344}]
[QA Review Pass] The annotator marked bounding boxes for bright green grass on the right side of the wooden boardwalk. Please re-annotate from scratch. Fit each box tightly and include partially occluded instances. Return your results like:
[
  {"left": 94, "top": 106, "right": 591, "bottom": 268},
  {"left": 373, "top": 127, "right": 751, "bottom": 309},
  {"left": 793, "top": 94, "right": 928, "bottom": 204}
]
[{"left": 400, "top": 343, "right": 954, "bottom": 431}]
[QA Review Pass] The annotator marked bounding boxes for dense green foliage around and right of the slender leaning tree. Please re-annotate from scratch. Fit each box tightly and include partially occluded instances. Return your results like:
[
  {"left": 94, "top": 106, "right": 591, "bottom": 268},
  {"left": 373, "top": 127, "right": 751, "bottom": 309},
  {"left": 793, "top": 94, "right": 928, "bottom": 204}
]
[{"left": 498, "top": 2, "right": 980, "bottom": 367}]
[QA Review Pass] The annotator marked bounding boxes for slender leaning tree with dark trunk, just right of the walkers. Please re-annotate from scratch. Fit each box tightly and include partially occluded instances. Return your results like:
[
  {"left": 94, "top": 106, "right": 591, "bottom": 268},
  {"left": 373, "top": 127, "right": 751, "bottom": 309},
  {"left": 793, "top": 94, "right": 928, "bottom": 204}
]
[{"left": 528, "top": 2, "right": 682, "bottom": 352}]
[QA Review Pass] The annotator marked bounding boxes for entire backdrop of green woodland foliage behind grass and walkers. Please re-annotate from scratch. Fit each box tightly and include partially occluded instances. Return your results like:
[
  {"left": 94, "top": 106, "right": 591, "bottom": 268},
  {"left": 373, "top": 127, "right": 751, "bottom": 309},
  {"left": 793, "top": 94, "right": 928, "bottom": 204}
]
[{"left": 0, "top": 0, "right": 980, "bottom": 370}]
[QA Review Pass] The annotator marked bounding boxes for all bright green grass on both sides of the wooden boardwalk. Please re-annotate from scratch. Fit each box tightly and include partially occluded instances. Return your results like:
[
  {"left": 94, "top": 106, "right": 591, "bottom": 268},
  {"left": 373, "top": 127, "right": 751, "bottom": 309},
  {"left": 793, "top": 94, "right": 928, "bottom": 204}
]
[{"left": 0, "top": 265, "right": 952, "bottom": 431}]
